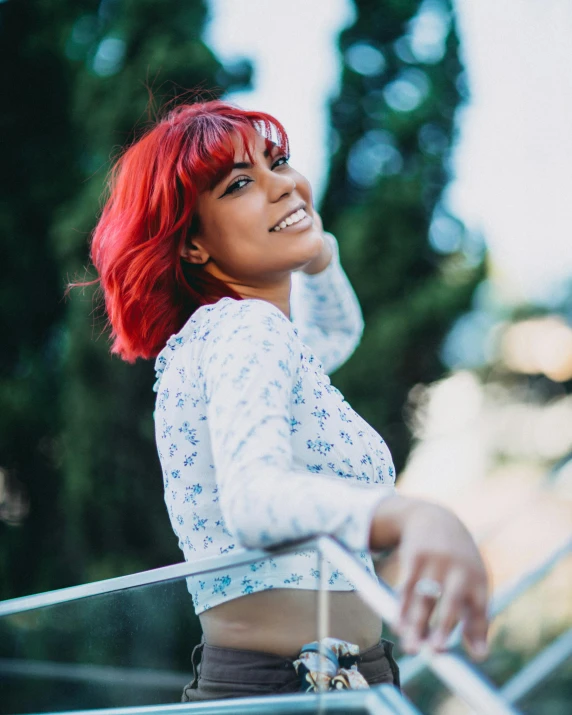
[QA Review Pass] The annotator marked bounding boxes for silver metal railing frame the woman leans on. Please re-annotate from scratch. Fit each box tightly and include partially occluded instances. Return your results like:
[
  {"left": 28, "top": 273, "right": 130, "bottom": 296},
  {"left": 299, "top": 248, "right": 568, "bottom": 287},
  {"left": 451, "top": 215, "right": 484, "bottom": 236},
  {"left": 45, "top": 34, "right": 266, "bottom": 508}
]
[{"left": 0, "top": 536, "right": 532, "bottom": 715}]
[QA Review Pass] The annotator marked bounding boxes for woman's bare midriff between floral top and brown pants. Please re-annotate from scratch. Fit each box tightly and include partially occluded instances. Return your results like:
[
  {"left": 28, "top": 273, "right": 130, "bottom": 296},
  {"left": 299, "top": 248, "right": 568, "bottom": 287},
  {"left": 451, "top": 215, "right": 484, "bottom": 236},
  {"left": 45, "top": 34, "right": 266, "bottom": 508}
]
[{"left": 199, "top": 588, "right": 382, "bottom": 657}]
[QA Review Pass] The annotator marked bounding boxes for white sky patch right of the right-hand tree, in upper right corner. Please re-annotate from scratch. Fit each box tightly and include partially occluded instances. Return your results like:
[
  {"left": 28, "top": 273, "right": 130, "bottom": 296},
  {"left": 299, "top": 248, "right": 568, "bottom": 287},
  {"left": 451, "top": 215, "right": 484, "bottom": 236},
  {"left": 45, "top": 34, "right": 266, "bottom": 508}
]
[{"left": 448, "top": 0, "right": 572, "bottom": 302}]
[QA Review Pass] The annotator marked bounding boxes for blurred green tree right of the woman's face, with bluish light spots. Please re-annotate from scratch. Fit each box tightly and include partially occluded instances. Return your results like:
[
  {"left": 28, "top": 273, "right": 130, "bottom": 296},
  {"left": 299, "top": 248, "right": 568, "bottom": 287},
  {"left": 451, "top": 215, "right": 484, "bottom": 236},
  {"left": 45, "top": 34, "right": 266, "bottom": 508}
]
[{"left": 321, "top": 0, "right": 483, "bottom": 473}]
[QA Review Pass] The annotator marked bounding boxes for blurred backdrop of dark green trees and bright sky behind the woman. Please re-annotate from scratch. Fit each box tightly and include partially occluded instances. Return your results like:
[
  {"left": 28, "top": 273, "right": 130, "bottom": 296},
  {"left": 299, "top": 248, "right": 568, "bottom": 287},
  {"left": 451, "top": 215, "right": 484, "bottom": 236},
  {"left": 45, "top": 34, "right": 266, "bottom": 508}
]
[{"left": 0, "top": 0, "right": 572, "bottom": 715}]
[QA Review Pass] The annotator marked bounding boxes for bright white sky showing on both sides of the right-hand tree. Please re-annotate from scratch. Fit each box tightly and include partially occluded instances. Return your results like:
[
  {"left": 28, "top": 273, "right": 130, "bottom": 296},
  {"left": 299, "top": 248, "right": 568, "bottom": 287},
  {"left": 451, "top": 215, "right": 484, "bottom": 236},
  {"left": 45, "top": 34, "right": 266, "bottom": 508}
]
[{"left": 205, "top": 0, "right": 572, "bottom": 304}]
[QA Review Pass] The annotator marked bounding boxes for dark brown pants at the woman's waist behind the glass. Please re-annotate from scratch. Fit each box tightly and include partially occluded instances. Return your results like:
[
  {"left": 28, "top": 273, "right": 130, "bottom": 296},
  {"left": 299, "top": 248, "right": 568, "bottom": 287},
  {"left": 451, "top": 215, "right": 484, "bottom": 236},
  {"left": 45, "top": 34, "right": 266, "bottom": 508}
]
[{"left": 181, "top": 637, "right": 400, "bottom": 703}]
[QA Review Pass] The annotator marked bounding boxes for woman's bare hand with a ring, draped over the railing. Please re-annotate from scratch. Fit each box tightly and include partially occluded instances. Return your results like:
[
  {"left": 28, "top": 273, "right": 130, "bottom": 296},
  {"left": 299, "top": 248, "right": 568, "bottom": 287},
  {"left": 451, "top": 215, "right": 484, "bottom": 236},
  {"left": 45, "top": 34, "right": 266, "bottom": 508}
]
[{"left": 370, "top": 494, "right": 489, "bottom": 660}]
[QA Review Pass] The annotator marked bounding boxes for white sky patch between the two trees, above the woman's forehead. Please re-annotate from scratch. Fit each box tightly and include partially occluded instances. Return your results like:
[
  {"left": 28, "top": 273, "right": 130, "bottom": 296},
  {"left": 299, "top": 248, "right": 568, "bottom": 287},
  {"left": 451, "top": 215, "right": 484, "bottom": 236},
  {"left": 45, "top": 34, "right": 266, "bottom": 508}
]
[{"left": 204, "top": 0, "right": 354, "bottom": 204}]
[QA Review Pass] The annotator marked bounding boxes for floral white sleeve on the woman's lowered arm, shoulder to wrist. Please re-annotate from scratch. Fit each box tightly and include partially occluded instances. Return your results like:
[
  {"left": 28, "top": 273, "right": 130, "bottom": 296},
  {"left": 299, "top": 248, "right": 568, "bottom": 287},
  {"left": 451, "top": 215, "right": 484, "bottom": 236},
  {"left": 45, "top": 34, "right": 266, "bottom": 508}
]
[{"left": 201, "top": 300, "right": 393, "bottom": 550}]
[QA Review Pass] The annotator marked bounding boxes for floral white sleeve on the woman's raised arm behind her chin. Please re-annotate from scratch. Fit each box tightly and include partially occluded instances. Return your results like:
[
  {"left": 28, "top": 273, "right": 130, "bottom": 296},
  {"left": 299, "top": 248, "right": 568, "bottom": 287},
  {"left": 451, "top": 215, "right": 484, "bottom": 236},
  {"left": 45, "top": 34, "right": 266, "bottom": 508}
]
[{"left": 290, "top": 233, "right": 364, "bottom": 373}]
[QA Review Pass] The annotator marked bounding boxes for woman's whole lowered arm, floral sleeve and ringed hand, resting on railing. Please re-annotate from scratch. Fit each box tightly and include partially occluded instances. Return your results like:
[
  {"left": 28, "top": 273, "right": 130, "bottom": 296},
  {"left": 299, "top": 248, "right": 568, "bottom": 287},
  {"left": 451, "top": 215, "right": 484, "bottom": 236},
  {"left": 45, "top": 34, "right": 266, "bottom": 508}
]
[{"left": 201, "top": 300, "right": 487, "bottom": 657}]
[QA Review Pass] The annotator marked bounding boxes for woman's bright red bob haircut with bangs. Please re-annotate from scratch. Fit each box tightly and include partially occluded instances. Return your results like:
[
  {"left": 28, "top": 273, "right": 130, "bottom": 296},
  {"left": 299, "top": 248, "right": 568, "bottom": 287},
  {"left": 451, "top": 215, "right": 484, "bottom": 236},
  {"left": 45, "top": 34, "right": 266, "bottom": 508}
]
[{"left": 84, "top": 100, "right": 289, "bottom": 362}]
